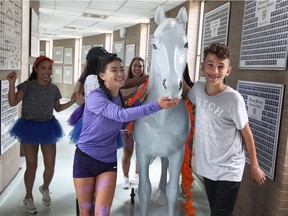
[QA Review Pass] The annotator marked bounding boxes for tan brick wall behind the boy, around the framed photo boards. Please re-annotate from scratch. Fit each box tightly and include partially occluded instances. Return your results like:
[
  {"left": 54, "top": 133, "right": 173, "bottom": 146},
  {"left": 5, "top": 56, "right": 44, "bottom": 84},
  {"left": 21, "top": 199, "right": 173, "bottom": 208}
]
[{"left": 205, "top": 1, "right": 288, "bottom": 216}]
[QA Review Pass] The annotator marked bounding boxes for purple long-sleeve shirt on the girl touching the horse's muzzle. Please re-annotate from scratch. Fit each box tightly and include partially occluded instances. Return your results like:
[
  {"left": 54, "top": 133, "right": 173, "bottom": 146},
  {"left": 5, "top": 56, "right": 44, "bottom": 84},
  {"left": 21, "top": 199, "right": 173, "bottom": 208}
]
[{"left": 77, "top": 88, "right": 161, "bottom": 162}]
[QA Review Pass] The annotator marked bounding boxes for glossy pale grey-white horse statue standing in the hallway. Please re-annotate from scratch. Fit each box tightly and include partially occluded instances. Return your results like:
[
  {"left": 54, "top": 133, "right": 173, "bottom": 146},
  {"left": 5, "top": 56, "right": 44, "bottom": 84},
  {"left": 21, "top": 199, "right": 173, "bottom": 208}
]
[{"left": 134, "top": 7, "right": 190, "bottom": 216}]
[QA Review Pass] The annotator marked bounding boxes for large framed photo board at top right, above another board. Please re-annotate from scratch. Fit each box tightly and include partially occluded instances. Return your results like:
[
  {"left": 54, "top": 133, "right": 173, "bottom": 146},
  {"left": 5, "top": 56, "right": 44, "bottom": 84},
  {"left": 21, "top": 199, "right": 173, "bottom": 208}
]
[{"left": 239, "top": 0, "right": 288, "bottom": 70}]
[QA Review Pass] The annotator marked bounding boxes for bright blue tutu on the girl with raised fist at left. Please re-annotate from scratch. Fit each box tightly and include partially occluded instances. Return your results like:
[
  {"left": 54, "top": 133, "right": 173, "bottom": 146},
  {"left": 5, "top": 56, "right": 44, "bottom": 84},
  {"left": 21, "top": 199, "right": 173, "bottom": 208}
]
[{"left": 9, "top": 118, "right": 64, "bottom": 145}]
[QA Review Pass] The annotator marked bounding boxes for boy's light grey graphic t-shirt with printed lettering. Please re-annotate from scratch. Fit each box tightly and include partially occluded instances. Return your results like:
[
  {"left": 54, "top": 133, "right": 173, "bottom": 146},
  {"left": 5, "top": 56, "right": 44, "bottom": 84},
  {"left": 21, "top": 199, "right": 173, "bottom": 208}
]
[{"left": 188, "top": 81, "right": 248, "bottom": 182}]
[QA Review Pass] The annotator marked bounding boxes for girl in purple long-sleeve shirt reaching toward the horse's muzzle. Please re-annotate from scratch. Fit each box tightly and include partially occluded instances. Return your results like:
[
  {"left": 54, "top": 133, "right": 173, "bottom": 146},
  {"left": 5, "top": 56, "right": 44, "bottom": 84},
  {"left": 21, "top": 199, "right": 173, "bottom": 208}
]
[{"left": 73, "top": 56, "right": 179, "bottom": 216}]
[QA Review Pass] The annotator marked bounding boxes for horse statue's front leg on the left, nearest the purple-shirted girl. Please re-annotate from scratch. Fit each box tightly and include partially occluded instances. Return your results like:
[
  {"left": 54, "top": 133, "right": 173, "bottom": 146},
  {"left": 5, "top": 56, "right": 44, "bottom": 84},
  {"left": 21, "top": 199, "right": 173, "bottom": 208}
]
[{"left": 136, "top": 145, "right": 152, "bottom": 216}]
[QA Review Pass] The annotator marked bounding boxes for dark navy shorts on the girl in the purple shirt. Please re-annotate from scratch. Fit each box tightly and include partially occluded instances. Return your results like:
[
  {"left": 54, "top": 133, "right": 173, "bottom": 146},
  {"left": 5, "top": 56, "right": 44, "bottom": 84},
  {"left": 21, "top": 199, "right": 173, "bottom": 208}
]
[{"left": 73, "top": 148, "right": 117, "bottom": 178}]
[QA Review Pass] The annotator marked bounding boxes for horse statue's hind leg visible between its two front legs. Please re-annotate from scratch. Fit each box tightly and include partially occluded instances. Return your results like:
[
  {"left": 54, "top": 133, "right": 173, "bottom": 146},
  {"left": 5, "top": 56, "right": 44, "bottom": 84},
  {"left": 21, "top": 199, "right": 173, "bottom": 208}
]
[{"left": 152, "top": 157, "right": 169, "bottom": 205}]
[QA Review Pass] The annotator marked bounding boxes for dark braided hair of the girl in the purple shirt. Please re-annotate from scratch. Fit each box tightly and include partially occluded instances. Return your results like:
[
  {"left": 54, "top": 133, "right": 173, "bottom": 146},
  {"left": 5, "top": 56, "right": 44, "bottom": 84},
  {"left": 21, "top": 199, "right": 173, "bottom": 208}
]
[{"left": 97, "top": 56, "right": 123, "bottom": 101}]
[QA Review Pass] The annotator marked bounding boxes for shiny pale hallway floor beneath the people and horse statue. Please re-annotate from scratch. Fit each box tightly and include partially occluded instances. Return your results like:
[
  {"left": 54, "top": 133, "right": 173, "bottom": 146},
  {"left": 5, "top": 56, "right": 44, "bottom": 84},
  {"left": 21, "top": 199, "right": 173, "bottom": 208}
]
[{"left": 0, "top": 99, "right": 210, "bottom": 216}]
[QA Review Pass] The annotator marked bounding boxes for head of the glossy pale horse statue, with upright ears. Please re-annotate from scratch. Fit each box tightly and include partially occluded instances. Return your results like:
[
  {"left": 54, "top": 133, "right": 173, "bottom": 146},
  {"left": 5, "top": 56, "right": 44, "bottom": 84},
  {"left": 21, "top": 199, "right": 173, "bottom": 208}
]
[{"left": 148, "top": 7, "right": 188, "bottom": 98}]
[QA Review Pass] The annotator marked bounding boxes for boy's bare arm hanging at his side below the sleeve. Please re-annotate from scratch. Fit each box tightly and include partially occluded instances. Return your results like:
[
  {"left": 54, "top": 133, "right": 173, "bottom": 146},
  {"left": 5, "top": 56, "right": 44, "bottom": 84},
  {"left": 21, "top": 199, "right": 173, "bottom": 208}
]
[{"left": 241, "top": 123, "right": 266, "bottom": 185}]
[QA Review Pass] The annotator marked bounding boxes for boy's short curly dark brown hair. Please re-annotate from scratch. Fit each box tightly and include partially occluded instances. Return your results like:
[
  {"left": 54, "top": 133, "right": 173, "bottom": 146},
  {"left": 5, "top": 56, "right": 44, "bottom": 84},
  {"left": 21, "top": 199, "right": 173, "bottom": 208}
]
[{"left": 203, "top": 43, "right": 230, "bottom": 61}]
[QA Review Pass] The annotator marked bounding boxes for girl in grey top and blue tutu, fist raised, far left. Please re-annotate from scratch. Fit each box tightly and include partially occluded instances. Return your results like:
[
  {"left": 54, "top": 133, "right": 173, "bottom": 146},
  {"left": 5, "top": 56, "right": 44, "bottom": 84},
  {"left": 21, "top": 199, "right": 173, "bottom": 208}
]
[{"left": 7, "top": 56, "right": 76, "bottom": 213}]
